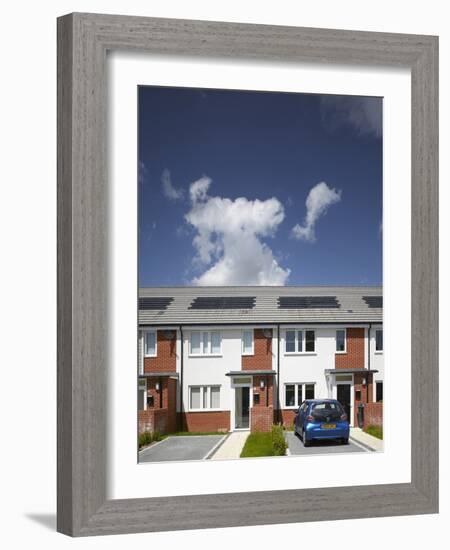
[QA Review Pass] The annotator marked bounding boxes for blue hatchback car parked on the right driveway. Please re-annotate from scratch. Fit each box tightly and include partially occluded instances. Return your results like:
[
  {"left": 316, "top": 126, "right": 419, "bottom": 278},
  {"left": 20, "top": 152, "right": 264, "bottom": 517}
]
[{"left": 294, "top": 399, "right": 350, "bottom": 447}]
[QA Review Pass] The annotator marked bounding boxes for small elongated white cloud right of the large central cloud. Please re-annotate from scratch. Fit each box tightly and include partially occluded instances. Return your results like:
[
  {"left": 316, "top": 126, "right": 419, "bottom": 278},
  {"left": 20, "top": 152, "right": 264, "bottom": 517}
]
[{"left": 291, "top": 181, "right": 341, "bottom": 242}]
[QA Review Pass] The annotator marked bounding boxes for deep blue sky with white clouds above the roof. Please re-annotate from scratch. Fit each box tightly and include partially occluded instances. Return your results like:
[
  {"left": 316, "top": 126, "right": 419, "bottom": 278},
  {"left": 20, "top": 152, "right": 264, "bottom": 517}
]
[{"left": 138, "top": 86, "right": 382, "bottom": 286}]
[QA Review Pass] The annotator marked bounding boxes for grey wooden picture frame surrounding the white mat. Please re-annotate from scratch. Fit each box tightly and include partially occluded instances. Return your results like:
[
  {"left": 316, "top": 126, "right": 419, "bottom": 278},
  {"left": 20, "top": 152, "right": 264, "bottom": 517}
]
[{"left": 57, "top": 13, "right": 438, "bottom": 536}]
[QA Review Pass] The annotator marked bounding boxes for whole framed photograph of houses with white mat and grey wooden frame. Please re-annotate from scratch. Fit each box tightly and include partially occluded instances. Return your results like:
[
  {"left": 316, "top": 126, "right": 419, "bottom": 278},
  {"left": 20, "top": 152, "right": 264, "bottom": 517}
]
[{"left": 58, "top": 14, "right": 438, "bottom": 536}]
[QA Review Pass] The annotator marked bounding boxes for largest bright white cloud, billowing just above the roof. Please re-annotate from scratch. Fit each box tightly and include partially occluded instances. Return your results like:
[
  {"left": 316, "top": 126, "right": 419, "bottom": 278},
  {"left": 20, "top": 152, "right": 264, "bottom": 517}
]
[{"left": 185, "top": 176, "right": 290, "bottom": 286}]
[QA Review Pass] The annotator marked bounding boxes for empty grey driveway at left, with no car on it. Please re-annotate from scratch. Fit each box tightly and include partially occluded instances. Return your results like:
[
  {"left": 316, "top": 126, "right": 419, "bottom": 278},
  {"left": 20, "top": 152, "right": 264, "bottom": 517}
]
[{"left": 139, "top": 435, "right": 226, "bottom": 462}]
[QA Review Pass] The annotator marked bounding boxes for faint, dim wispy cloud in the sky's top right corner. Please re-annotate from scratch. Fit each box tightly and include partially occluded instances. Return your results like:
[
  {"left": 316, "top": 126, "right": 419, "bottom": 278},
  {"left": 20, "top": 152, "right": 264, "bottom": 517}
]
[{"left": 320, "top": 95, "right": 383, "bottom": 138}]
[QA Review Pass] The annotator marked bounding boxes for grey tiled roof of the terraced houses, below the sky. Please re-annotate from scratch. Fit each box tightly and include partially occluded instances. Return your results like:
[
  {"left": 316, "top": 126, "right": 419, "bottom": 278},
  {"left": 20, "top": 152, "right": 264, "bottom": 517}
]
[{"left": 139, "top": 286, "right": 383, "bottom": 326}]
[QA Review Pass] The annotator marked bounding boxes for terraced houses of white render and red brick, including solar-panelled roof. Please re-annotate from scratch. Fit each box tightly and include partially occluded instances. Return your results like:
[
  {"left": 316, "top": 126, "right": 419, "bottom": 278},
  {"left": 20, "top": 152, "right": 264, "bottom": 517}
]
[{"left": 138, "top": 286, "right": 383, "bottom": 433}]
